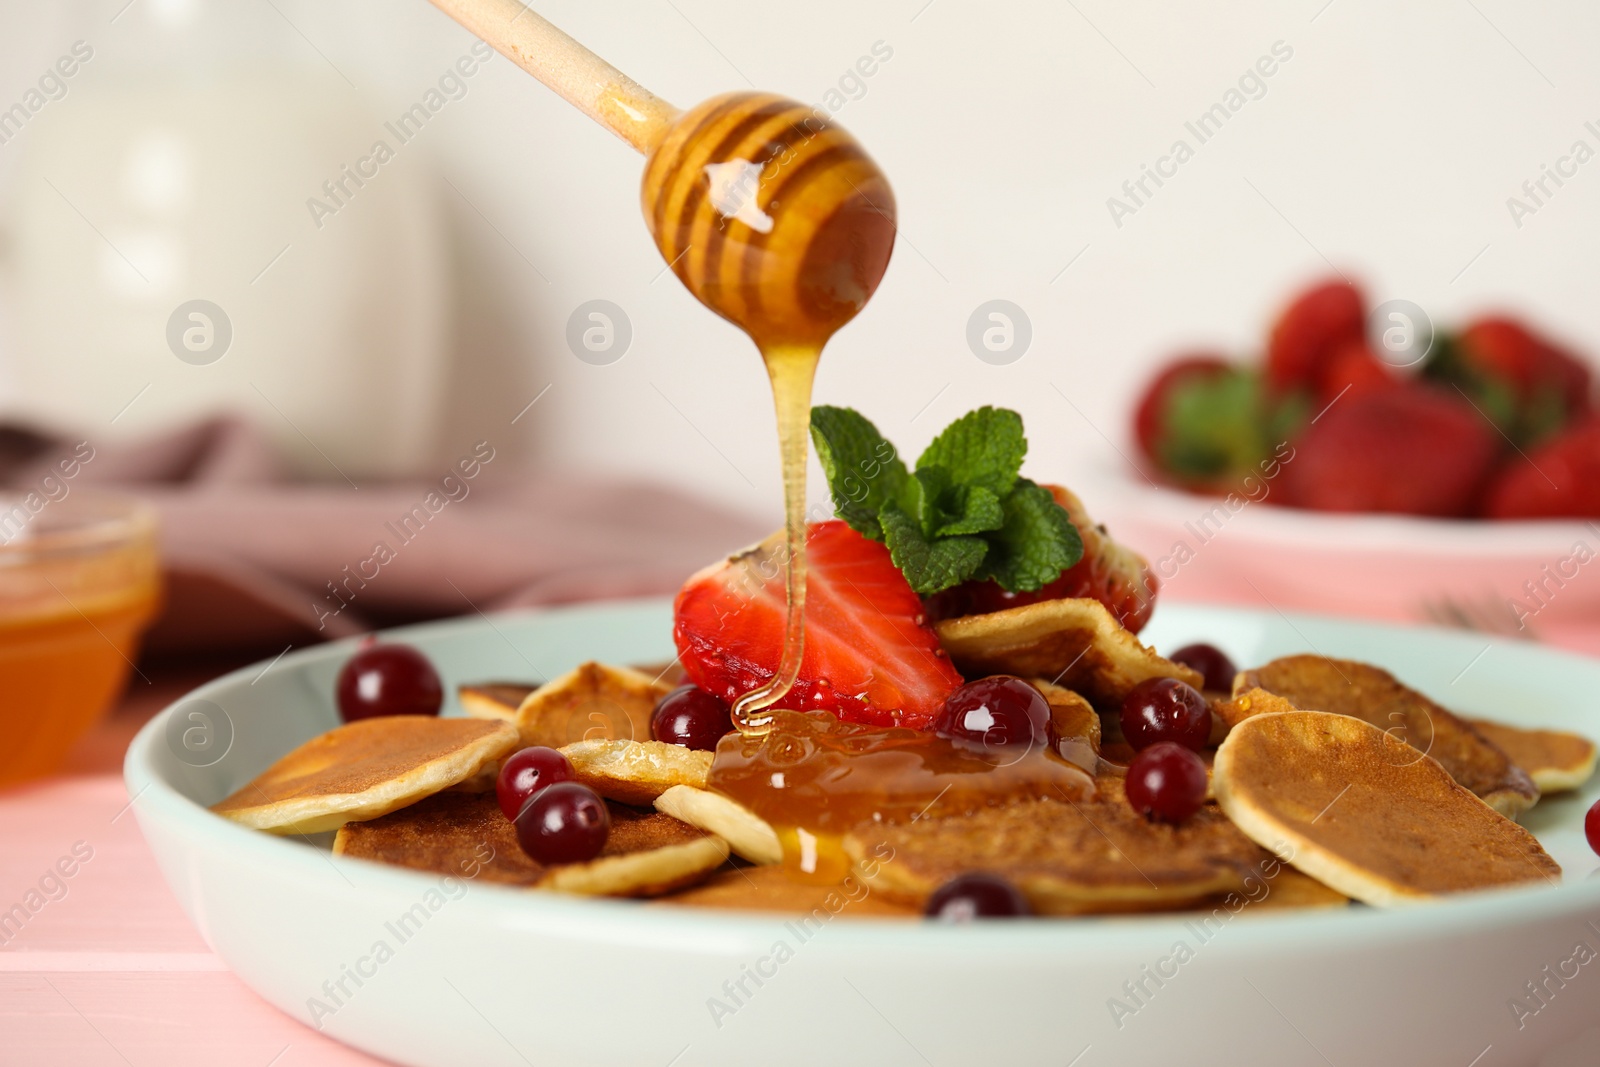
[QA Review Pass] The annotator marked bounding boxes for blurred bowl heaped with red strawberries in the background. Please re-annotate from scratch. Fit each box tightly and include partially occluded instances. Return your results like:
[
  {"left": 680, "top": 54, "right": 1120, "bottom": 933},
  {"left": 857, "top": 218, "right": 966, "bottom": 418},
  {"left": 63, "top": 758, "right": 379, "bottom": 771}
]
[{"left": 1107, "top": 277, "right": 1600, "bottom": 637}]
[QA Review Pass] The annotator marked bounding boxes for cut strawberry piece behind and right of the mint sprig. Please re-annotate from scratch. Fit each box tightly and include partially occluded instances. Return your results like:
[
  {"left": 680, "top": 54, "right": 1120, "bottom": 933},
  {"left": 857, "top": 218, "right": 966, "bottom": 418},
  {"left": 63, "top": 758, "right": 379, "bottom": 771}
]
[{"left": 928, "top": 485, "right": 1160, "bottom": 633}]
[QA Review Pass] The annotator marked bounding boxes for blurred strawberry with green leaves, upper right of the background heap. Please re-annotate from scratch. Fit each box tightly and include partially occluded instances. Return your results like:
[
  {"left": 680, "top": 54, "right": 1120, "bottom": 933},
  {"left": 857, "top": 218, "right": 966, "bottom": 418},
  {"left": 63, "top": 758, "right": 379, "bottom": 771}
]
[{"left": 1424, "top": 315, "right": 1592, "bottom": 448}]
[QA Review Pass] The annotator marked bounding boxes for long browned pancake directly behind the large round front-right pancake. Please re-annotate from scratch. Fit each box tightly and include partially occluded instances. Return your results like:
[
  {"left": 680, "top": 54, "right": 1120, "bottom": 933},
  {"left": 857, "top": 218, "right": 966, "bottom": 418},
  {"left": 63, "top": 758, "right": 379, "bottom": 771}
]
[{"left": 1234, "top": 656, "right": 1539, "bottom": 816}]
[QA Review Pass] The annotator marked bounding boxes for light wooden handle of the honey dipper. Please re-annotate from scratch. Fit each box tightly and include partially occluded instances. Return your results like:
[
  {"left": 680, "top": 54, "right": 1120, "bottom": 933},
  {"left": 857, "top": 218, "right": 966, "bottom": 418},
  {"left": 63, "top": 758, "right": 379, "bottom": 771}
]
[{"left": 432, "top": 0, "right": 678, "bottom": 155}]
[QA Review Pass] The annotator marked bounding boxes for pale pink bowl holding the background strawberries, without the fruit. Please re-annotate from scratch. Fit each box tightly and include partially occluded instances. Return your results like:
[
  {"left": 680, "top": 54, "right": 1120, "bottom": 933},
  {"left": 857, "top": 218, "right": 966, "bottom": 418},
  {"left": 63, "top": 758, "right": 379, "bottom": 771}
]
[{"left": 1082, "top": 464, "right": 1600, "bottom": 637}]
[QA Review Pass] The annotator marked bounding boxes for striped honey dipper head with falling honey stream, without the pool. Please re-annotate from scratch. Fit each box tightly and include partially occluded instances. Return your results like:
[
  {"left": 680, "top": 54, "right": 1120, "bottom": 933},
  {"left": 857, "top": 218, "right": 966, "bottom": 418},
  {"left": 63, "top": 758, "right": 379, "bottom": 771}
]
[{"left": 642, "top": 93, "right": 894, "bottom": 736}]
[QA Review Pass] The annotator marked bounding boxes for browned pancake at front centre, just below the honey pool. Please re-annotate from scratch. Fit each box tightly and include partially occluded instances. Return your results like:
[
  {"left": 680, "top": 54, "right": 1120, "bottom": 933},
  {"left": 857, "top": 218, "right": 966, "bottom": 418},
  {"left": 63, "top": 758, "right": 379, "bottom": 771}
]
[{"left": 845, "top": 790, "right": 1270, "bottom": 915}]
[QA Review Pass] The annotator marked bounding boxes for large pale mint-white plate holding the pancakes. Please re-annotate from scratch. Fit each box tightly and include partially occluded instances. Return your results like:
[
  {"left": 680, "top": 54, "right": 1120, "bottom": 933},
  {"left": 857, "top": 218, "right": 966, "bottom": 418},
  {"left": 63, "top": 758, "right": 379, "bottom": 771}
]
[{"left": 126, "top": 601, "right": 1600, "bottom": 1067}]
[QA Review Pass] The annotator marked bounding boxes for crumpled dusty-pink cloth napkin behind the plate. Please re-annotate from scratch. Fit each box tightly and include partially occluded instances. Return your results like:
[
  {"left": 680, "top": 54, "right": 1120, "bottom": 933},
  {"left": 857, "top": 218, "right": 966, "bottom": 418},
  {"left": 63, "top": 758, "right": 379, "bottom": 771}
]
[{"left": 0, "top": 418, "right": 770, "bottom": 651}]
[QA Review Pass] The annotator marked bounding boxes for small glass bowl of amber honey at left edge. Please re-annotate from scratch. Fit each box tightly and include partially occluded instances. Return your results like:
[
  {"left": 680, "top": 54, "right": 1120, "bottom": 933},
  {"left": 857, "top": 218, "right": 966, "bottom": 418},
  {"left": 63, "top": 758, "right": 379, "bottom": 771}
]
[{"left": 0, "top": 491, "right": 162, "bottom": 789}]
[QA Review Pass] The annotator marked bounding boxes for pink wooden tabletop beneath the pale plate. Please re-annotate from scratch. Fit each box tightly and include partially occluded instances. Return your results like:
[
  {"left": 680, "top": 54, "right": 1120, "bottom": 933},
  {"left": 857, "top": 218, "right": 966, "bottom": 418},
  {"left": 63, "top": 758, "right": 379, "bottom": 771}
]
[{"left": 12, "top": 620, "right": 1600, "bottom": 1067}]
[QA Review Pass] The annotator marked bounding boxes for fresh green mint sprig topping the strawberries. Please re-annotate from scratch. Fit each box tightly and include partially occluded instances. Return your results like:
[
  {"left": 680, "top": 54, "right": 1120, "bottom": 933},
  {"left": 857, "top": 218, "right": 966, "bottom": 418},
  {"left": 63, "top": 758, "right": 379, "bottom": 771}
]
[{"left": 811, "top": 406, "right": 1083, "bottom": 597}]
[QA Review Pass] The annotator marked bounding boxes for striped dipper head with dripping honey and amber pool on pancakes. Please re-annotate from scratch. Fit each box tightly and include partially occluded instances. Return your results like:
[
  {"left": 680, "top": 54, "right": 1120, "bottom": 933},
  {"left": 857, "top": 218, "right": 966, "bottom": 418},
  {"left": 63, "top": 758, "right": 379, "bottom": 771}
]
[{"left": 642, "top": 93, "right": 1093, "bottom": 881}]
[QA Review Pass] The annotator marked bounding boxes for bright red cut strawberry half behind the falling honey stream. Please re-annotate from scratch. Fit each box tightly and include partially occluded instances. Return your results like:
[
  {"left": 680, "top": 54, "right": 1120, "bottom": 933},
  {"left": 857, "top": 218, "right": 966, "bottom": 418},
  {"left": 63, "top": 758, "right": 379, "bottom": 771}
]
[{"left": 672, "top": 520, "right": 962, "bottom": 729}]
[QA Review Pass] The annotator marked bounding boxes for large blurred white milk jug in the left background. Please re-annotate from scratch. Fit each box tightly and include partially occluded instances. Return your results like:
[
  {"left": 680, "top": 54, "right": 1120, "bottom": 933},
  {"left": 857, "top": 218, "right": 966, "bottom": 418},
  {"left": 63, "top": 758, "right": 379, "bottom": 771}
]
[{"left": 0, "top": 0, "right": 450, "bottom": 483}]
